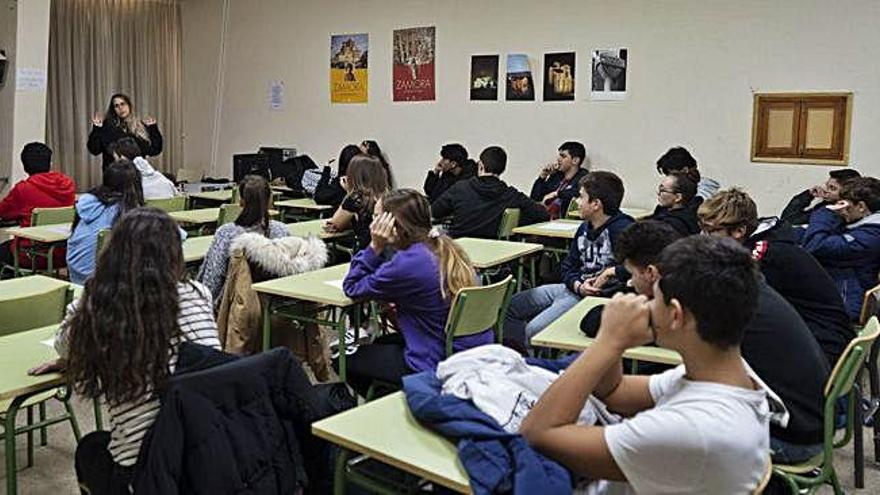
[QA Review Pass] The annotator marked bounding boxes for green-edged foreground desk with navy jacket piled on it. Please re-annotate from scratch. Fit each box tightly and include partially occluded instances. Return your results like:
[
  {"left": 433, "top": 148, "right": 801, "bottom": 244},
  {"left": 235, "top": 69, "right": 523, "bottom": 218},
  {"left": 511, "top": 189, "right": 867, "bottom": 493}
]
[{"left": 312, "top": 392, "right": 472, "bottom": 493}]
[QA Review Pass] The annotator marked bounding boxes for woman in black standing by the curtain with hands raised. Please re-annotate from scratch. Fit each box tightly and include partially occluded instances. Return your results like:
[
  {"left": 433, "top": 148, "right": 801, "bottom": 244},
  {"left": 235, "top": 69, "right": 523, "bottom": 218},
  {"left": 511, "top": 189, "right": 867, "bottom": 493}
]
[{"left": 88, "top": 93, "right": 162, "bottom": 170}]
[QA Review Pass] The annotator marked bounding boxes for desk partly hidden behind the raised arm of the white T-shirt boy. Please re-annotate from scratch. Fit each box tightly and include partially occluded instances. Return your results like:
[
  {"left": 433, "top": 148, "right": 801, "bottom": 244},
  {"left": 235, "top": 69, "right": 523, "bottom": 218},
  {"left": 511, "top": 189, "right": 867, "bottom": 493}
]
[{"left": 531, "top": 297, "right": 681, "bottom": 370}]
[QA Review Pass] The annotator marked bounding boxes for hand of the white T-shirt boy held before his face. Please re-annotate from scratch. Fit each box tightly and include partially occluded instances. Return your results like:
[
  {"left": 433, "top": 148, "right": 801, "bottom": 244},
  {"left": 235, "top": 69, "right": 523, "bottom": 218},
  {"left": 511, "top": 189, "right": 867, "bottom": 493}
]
[{"left": 596, "top": 294, "right": 654, "bottom": 353}]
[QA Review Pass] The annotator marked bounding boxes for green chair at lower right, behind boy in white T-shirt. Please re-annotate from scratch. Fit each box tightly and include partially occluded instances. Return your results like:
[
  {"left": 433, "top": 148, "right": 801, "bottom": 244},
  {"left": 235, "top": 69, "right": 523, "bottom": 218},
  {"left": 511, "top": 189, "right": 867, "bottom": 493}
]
[{"left": 773, "top": 317, "right": 880, "bottom": 494}]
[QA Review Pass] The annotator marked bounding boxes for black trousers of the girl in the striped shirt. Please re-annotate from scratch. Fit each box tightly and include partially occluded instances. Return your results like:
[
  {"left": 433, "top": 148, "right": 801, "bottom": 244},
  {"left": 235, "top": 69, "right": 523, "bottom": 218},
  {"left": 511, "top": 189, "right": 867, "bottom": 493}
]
[{"left": 74, "top": 431, "right": 133, "bottom": 495}]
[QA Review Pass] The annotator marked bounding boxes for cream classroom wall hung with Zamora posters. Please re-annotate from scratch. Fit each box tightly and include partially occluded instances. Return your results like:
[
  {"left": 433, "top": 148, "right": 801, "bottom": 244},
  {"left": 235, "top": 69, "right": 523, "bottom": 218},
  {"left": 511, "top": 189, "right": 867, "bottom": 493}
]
[{"left": 184, "top": 0, "right": 880, "bottom": 214}]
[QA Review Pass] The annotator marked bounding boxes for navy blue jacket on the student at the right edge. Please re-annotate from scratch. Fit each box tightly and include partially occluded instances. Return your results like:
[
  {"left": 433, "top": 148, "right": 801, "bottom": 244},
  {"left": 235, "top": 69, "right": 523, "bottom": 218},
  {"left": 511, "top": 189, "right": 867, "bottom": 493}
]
[{"left": 801, "top": 208, "right": 880, "bottom": 319}]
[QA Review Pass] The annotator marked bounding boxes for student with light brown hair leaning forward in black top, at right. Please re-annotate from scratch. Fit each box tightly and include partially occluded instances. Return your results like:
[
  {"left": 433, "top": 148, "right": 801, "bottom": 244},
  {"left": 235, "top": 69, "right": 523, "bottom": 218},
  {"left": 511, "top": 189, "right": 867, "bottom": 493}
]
[{"left": 698, "top": 188, "right": 856, "bottom": 368}]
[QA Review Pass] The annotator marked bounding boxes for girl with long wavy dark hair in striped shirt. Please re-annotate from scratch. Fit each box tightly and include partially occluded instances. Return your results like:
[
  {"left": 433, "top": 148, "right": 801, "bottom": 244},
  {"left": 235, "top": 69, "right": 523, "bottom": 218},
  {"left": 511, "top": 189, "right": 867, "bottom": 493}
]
[{"left": 30, "top": 208, "right": 220, "bottom": 494}]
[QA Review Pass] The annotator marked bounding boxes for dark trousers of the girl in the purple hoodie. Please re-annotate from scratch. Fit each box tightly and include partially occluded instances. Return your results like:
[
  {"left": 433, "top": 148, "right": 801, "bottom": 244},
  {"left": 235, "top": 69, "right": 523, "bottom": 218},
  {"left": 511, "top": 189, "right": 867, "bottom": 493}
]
[{"left": 333, "top": 333, "right": 413, "bottom": 397}]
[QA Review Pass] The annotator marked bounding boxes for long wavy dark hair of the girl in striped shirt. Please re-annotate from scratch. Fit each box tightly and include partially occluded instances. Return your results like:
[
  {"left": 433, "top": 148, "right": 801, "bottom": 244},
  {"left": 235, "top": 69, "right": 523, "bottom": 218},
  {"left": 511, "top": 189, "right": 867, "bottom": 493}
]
[{"left": 66, "top": 208, "right": 184, "bottom": 406}]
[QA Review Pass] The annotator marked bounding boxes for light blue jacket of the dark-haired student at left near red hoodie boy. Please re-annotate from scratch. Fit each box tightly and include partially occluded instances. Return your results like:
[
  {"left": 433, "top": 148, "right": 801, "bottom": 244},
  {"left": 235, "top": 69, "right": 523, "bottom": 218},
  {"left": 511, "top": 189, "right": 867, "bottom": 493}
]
[{"left": 67, "top": 194, "right": 119, "bottom": 285}]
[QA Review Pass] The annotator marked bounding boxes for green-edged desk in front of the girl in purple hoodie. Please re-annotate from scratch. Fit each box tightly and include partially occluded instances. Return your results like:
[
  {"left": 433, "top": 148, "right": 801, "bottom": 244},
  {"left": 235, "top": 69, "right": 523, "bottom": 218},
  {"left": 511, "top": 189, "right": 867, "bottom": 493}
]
[{"left": 251, "top": 263, "right": 360, "bottom": 382}]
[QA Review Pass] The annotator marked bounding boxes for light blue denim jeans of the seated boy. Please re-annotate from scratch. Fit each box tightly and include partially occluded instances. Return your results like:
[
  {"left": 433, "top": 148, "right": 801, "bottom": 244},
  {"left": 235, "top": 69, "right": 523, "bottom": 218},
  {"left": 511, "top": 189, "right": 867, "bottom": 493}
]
[{"left": 504, "top": 284, "right": 581, "bottom": 347}]
